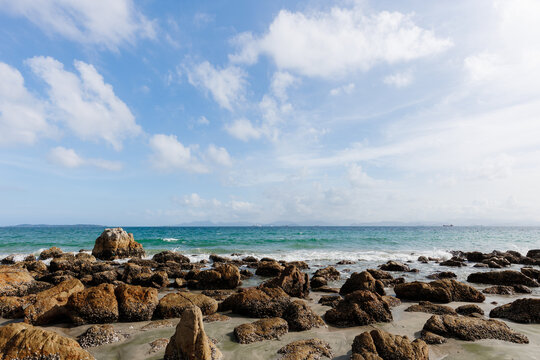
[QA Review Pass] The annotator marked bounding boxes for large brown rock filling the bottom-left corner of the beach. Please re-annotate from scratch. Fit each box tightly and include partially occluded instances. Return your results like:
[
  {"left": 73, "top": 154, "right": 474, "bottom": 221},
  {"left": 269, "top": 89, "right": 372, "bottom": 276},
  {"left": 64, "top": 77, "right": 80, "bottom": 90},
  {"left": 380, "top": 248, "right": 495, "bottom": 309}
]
[{"left": 0, "top": 323, "right": 95, "bottom": 360}]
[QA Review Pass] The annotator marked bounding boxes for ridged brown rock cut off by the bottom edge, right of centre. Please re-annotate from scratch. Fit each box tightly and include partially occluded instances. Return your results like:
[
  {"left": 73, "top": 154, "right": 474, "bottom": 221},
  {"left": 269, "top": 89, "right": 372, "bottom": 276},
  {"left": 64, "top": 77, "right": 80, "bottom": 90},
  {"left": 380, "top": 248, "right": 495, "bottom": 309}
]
[{"left": 351, "top": 330, "right": 429, "bottom": 360}]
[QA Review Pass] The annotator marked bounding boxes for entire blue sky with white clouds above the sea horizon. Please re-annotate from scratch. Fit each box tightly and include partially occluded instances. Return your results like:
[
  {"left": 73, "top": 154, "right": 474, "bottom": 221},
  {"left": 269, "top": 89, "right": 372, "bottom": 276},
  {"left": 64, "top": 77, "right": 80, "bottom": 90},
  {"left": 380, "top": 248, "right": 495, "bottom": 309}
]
[{"left": 0, "top": 0, "right": 540, "bottom": 225}]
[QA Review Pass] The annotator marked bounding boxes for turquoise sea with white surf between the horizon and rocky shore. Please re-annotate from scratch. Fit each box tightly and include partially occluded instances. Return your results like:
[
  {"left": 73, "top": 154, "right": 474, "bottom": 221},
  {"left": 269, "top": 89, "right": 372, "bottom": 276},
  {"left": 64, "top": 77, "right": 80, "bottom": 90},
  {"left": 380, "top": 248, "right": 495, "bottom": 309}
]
[{"left": 0, "top": 226, "right": 540, "bottom": 261}]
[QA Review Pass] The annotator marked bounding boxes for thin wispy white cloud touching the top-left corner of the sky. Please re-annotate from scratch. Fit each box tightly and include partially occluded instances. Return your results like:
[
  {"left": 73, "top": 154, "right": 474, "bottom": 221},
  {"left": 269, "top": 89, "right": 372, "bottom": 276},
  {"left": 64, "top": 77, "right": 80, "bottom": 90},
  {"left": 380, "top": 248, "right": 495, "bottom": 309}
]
[{"left": 0, "top": 0, "right": 155, "bottom": 50}]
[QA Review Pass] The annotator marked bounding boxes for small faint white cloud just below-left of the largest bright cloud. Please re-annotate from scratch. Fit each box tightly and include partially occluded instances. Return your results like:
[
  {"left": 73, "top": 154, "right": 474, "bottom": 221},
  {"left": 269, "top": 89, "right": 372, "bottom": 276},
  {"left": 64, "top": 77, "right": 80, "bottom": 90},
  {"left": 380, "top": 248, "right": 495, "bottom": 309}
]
[{"left": 187, "top": 61, "right": 246, "bottom": 110}]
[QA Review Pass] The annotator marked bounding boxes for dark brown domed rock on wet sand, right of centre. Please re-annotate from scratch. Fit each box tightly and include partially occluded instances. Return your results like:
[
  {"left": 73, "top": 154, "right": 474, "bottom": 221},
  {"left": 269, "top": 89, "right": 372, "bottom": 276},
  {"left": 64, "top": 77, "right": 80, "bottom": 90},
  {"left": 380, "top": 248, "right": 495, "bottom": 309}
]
[{"left": 324, "top": 290, "right": 392, "bottom": 327}]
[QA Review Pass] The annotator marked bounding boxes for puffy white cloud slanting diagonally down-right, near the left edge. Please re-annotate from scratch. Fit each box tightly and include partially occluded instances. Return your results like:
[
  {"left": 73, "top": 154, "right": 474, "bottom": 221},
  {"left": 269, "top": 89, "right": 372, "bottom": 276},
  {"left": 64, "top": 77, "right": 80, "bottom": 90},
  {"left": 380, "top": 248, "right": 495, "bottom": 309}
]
[{"left": 27, "top": 56, "right": 141, "bottom": 150}]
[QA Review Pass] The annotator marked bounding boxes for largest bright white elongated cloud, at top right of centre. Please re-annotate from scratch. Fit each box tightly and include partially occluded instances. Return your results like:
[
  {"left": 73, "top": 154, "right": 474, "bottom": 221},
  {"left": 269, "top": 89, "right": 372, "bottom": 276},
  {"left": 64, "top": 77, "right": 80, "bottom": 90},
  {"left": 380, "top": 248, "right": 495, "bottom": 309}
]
[{"left": 230, "top": 7, "right": 452, "bottom": 78}]
